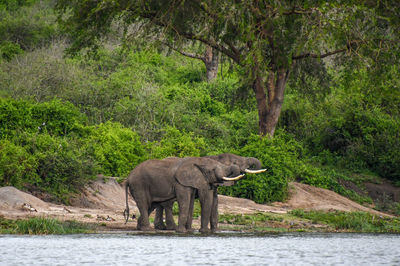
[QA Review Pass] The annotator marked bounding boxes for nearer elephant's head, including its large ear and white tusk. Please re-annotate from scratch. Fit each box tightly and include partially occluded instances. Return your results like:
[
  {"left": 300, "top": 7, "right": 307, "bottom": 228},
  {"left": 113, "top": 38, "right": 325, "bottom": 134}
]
[{"left": 175, "top": 158, "right": 244, "bottom": 189}]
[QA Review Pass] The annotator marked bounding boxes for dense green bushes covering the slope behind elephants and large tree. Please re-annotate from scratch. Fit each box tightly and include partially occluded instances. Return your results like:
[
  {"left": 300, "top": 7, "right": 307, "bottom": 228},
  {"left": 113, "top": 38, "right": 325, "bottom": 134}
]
[{"left": 0, "top": 1, "right": 400, "bottom": 210}]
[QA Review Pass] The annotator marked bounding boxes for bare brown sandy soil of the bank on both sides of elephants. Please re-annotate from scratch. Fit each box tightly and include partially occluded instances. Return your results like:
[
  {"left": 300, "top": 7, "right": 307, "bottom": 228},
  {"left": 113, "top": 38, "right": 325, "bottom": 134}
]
[{"left": 0, "top": 177, "right": 389, "bottom": 230}]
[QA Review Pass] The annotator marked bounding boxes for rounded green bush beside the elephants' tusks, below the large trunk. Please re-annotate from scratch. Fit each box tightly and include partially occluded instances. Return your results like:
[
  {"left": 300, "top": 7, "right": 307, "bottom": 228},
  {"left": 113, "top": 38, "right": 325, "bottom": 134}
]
[{"left": 220, "top": 131, "right": 304, "bottom": 203}]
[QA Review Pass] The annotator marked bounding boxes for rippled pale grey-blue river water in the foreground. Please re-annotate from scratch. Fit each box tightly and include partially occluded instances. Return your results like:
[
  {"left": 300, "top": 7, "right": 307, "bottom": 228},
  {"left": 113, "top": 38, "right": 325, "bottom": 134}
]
[{"left": 0, "top": 233, "right": 400, "bottom": 265}]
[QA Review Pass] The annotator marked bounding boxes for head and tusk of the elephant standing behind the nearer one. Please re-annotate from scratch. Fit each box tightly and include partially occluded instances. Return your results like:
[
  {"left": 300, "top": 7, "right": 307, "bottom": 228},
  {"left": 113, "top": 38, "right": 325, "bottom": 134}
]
[{"left": 213, "top": 153, "right": 265, "bottom": 174}]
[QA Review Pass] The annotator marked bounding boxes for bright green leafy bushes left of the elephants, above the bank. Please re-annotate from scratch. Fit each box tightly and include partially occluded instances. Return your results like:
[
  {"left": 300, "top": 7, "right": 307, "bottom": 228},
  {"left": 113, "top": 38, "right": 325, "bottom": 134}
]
[{"left": 0, "top": 99, "right": 144, "bottom": 202}]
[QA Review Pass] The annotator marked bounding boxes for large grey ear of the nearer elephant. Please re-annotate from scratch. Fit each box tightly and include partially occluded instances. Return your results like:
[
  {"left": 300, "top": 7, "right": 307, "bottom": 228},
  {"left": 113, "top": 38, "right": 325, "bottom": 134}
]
[{"left": 175, "top": 164, "right": 211, "bottom": 189}]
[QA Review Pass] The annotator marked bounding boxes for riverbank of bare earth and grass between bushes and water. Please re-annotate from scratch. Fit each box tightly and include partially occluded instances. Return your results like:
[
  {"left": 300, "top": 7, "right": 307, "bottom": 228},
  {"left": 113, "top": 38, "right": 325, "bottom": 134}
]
[{"left": 0, "top": 177, "right": 400, "bottom": 234}]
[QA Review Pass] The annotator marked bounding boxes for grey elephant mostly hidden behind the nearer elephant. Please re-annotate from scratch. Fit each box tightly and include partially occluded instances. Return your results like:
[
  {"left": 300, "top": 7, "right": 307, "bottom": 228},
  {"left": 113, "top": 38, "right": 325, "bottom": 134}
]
[{"left": 154, "top": 153, "right": 266, "bottom": 231}]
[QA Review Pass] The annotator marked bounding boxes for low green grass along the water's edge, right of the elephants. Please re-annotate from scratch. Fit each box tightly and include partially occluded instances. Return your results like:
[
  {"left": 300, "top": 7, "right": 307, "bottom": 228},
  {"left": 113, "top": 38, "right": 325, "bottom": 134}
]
[{"left": 290, "top": 210, "right": 400, "bottom": 233}]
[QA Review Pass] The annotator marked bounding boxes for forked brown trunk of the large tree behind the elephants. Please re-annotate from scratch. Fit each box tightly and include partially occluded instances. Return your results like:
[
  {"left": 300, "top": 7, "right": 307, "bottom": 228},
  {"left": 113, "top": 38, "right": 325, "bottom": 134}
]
[{"left": 253, "top": 69, "right": 288, "bottom": 137}]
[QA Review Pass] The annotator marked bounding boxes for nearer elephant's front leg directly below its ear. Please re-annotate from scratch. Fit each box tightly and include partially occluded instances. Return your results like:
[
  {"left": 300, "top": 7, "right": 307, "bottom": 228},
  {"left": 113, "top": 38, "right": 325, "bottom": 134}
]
[{"left": 175, "top": 184, "right": 193, "bottom": 233}]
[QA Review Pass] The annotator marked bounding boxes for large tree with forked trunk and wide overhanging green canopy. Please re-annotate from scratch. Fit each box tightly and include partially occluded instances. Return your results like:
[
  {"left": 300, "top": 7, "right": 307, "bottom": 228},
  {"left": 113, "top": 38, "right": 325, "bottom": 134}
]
[{"left": 58, "top": 0, "right": 400, "bottom": 136}]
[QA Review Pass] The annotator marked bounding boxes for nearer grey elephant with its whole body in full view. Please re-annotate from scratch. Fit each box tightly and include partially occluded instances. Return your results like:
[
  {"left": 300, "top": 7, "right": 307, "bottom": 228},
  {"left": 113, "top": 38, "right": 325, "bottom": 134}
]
[{"left": 124, "top": 157, "right": 243, "bottom": 233}]
